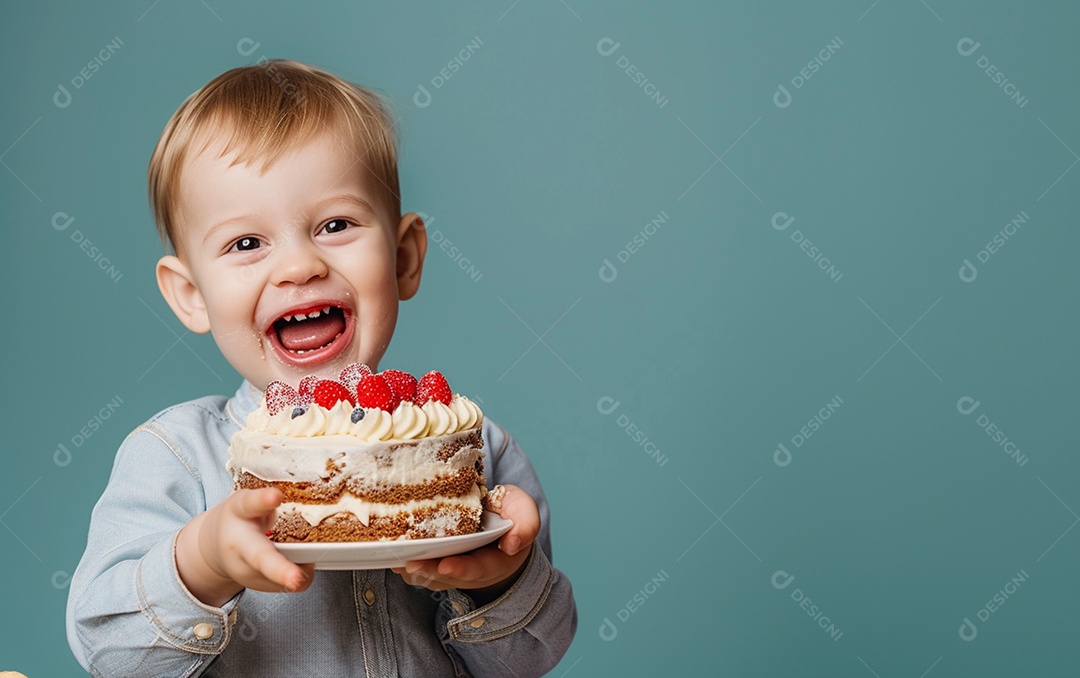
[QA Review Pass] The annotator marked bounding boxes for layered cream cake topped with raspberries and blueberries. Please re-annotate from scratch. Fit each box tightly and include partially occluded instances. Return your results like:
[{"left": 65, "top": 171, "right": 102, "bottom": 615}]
[{"left": 227, "top": 364, "right": 487, "bottom": 542}]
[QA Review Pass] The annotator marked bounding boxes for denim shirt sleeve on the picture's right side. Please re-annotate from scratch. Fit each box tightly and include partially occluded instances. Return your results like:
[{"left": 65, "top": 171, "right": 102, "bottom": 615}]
[{"left": 436, "top": 421, "right": 578, "bottom": 676}]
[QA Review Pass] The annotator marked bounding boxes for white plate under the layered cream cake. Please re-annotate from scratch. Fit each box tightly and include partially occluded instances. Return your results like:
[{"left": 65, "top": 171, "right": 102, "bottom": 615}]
[{"left": 274, "top": 511, "right": 514, "bottom": 570}]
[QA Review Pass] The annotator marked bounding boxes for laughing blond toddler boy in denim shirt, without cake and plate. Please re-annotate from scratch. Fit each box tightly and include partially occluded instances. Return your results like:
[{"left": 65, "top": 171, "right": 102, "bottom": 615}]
[{"left": 67, "top": 62, "right": 577, "bottom": 677}]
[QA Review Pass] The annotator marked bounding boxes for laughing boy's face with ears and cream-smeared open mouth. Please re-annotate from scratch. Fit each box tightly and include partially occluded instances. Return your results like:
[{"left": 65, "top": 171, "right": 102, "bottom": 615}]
[{"left": 158, "top": 131, "right": 427, "bottom": 389}]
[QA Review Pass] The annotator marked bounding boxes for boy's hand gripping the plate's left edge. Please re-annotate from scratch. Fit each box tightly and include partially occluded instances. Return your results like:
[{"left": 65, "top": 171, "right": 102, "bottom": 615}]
[{"left": 176, "top": 488, "right": 314, "bottom": 607}]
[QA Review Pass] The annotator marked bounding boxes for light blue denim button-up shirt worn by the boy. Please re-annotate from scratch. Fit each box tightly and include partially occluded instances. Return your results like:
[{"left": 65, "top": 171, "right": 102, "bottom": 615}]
[{"left": 67, "top": 381, "right": 577, "bottom": 678}]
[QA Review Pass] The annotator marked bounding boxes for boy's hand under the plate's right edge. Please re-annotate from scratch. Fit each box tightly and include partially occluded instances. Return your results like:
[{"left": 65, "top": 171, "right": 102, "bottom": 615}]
[{"left": 393, "top": 485, "right": 540, "bottom": 606}]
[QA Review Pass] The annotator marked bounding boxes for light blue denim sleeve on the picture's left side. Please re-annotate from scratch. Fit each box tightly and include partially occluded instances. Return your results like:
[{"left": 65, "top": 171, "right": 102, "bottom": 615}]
[{"left": 67, "top": 422, "right": 243, "bottom": 676}]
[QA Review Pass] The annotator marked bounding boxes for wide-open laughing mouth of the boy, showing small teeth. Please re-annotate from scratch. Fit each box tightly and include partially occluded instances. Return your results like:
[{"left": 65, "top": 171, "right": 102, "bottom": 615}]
[{"left": 267, "top": 303, "right": 353, "bottom": 366}]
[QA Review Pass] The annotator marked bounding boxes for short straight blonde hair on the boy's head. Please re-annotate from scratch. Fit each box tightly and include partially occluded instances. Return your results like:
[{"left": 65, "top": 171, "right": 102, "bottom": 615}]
[{"left": 147, "top": 59, "right": 401, "bottom": 249}]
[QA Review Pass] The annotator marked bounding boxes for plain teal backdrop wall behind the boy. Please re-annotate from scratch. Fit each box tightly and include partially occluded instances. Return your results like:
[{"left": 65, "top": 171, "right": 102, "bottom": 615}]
[{"left": 0, "top": 0, "right": 1080, "bottom": 678}]
